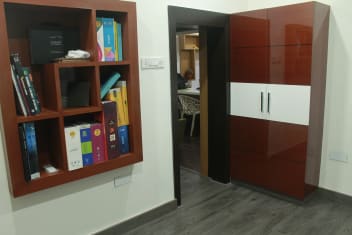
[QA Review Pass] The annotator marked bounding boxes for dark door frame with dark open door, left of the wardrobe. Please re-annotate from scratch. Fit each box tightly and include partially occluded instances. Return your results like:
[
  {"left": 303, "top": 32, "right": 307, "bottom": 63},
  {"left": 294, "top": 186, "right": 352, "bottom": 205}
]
[{"left": 168, "top": 6, "right": 230, "bottom": 205}]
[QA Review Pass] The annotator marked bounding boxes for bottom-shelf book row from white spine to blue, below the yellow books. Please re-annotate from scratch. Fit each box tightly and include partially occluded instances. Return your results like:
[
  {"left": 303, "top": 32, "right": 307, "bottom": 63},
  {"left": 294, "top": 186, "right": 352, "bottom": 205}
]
[{"left": 65, "top": 98, "right": 130, "bottom": 170}]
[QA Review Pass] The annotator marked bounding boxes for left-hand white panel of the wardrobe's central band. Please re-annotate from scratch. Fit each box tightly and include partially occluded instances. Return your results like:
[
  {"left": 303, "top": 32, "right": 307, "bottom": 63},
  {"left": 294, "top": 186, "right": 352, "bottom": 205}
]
[{"left": 230, "top": 82, "right": 267, "bottom": 119}]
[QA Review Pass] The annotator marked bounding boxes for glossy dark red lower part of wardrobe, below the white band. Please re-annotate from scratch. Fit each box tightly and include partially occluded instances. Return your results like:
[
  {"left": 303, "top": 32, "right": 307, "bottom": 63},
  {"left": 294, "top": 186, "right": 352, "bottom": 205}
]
[{"left": 230, "top": 116, "right": 308, "bottom": 199}]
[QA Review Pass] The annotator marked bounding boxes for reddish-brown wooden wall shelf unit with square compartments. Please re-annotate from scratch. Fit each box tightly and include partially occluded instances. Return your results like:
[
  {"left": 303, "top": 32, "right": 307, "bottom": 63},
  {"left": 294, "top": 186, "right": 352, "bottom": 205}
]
[{"left": 0, "top": 0, "right": 142, "bottom": 197}]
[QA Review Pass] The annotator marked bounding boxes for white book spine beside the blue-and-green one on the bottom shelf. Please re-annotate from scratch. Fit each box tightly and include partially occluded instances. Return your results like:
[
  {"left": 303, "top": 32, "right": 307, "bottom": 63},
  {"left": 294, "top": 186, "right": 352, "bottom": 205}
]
[{"left": 65, "top": 126, "right": 83, "bottom": 171}]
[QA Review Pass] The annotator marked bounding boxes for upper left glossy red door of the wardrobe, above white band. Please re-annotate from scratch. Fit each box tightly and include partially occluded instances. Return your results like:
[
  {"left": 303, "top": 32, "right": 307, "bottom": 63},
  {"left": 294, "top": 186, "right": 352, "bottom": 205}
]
[{"left": 230, "top": 10, "right": 269, "bottom": 83}]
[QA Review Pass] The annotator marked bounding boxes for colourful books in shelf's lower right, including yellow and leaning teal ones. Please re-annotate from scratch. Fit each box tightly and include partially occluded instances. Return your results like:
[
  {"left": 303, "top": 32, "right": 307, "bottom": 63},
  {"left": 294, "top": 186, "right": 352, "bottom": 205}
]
[{"left": 65, "top": 72, "right": 130, "bottom": 171}]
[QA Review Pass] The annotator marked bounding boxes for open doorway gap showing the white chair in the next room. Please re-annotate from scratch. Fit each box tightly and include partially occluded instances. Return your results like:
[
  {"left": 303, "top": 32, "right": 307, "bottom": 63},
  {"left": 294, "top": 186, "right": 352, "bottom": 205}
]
[{"left": 175, "top": 29, "right": 201, "bottom": 175}]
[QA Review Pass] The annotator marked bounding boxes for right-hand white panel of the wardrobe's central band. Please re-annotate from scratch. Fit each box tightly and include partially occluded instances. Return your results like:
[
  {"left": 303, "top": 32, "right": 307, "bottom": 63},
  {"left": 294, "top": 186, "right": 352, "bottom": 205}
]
[{"left": 267, "top": 84, "right": 310, "bottom": 125}]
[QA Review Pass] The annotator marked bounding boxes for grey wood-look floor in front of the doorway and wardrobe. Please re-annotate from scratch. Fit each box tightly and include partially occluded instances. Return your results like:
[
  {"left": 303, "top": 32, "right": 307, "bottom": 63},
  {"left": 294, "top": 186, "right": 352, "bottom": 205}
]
[{"left": 128, "top": 169, "right": 352, "bottom": 235}]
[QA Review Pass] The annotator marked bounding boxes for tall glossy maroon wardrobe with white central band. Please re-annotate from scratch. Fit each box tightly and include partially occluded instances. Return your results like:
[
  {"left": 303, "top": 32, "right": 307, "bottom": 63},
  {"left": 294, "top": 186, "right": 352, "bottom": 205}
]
[{"left": 230, "top": 2, "right": 329, "bottom": 199}]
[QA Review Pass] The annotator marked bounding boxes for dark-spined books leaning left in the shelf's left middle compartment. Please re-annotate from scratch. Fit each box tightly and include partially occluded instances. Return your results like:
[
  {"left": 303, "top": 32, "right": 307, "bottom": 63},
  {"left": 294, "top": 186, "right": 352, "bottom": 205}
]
[{"left": 10, "top": 53, "right": 41, "bottom": 116}]
